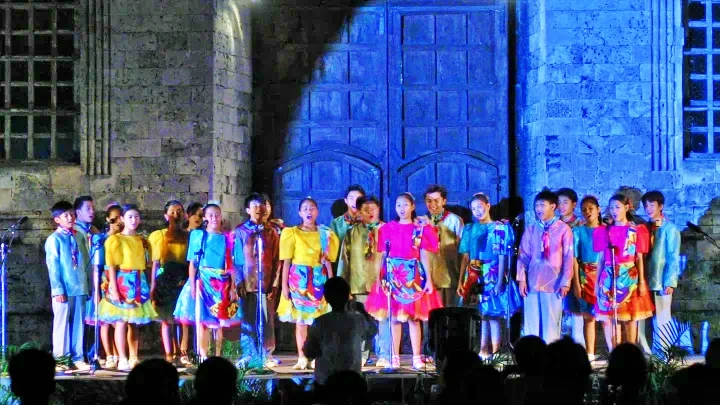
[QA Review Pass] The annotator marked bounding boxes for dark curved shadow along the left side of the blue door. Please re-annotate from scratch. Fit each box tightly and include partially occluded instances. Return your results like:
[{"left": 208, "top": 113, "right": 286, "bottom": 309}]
[{"left": 252, "top": 0, "right": 371, "bottom": 195}]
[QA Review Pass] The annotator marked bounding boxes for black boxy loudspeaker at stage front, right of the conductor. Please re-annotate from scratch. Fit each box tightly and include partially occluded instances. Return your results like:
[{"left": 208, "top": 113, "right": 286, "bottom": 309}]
[{"left": 428, "top": 307, "right": 482, "bottom": 366}]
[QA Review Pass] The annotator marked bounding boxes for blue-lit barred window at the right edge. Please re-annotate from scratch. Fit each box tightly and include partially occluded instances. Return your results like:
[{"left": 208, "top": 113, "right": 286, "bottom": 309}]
[{"left": 683, "top": 0, "right": 720, "bottom": 156}]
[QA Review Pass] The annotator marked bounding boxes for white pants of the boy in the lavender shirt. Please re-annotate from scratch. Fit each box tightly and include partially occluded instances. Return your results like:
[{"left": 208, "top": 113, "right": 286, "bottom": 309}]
[{"left": 523, "top": 291, "right": 562, "bottom": 344}]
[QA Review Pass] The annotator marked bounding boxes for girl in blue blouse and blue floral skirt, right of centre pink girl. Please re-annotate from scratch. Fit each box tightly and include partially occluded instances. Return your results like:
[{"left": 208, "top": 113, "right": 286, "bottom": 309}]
[{"left": 457, "top": 193, "right": 522, "bottom": 358}]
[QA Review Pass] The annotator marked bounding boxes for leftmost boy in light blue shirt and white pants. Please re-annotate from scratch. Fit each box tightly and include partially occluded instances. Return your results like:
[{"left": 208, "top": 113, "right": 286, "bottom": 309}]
[{"left": 45, "top": 201, "right": 90, "bottom": 371}]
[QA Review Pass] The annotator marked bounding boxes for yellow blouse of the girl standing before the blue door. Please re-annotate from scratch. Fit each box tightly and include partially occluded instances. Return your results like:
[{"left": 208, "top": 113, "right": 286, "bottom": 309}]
[{"left": 280, "top": 226, "right": 340, "bottom": 267}]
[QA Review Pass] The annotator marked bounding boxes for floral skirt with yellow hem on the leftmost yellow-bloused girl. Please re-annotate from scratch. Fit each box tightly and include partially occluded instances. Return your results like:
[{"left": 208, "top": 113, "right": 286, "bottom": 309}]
[{"left": 98, "top": 270, "right": 158, "bottom": 325}]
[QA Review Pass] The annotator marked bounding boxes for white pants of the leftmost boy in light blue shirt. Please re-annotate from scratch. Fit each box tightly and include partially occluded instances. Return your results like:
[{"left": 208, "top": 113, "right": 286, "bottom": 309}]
[{"left": 52, "top": 295, "right": 87, "bottom": 362}]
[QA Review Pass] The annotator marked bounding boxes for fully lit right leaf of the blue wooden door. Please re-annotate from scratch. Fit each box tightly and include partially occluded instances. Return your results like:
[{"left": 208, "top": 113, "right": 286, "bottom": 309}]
[{"left": 388, "top": 0, "right": 509, "bottom": 218}]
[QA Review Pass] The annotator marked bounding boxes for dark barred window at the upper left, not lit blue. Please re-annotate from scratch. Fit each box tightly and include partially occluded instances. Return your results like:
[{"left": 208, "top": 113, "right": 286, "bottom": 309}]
[{"left": 0, "top": 0, "right": 80, "bottom": 163}]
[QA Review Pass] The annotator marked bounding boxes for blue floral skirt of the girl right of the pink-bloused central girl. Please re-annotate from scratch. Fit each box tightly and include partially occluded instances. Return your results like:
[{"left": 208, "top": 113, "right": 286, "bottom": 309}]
[{"left": 476, "top": 262, "right": 522, "bottom": 318}]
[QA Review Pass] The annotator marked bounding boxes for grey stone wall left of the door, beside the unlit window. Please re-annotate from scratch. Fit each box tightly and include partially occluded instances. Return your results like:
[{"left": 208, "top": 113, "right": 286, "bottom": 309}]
[{"left": 0, "top": 0, "right": 251, "bottom": 347}]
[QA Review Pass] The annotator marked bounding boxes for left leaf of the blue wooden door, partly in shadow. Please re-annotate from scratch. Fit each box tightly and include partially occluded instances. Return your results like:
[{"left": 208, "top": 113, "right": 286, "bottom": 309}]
[{"left": 265, "top": 2, "right": 388, "bottom": 224}]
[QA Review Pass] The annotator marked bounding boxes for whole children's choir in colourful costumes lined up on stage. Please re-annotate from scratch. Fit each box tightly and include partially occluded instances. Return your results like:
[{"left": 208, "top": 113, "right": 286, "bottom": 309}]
[{"left": 45, "top": 185, "right": 680, "bottom": 370}]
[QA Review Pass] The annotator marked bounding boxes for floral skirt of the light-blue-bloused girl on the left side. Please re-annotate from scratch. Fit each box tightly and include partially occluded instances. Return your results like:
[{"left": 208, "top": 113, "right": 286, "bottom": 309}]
[{"left": 173, "top": 267, "right": 242, "bottom": 329}]
